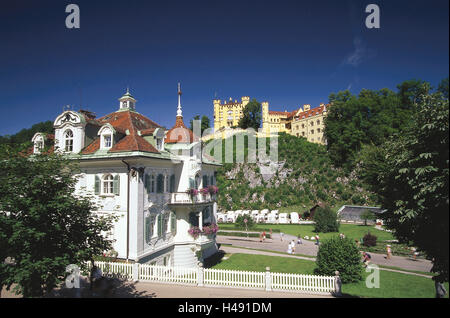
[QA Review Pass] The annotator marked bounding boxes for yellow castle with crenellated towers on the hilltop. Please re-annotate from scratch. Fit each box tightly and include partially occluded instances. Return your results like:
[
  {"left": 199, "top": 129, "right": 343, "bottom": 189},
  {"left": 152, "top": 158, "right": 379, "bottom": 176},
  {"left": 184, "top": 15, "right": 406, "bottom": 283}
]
[{"left": 208, "top": 96, "right": 330, "bottom": 144}]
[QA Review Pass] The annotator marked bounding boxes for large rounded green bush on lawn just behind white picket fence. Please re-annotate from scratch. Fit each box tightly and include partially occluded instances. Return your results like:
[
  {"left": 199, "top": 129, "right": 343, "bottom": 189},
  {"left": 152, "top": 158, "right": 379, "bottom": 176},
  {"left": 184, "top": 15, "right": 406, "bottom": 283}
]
[{"left": 314, "top": 236, "right": 363, "bottom": 284}]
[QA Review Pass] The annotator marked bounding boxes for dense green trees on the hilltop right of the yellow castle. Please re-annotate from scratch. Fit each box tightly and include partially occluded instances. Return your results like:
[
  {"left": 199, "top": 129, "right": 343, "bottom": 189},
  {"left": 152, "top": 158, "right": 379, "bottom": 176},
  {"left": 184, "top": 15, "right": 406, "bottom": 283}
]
[{"left": 324, "top": 80, "right": 420, "bottom": 170}]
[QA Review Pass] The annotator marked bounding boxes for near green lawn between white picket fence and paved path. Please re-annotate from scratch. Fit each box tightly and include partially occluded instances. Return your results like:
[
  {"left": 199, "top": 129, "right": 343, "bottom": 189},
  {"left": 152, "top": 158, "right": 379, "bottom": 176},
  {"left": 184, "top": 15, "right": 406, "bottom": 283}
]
[{"left": 213, "top": 254, "right": 449, "bottom": 298}]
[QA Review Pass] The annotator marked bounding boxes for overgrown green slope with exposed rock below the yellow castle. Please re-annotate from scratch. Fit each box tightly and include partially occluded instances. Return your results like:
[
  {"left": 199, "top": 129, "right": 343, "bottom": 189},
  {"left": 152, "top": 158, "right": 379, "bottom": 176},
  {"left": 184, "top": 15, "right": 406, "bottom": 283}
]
[{"left": 217, "top": 134, "right": 376, "bottom": 212}]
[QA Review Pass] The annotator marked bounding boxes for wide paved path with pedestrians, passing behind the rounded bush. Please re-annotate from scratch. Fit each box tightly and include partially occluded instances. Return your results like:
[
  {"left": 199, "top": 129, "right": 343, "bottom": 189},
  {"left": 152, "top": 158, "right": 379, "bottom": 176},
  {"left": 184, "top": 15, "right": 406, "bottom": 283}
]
[{"left": 217, "top": 233, "right": 432, "bottom": 272}]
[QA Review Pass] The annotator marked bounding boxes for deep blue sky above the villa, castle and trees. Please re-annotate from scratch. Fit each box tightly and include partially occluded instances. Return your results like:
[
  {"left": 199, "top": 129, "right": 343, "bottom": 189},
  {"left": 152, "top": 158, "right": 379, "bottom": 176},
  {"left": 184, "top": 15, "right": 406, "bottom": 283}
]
[{"left": 0, "top": 0, "right": 449, "bottom": 135}]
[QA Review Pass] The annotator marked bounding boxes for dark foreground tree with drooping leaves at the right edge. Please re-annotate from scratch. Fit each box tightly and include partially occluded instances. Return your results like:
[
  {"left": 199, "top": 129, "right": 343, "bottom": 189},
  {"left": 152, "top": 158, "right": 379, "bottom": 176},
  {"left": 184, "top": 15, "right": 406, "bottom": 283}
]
[{"left": 363, "top": 86, "right": 449, "bottom": 288}]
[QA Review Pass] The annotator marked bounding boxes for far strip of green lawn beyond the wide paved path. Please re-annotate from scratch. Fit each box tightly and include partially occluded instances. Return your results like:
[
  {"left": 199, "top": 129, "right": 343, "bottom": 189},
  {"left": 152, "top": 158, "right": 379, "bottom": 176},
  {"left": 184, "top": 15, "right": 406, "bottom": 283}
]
[{"left": 219, "top": 223, "right": 395, "bottom": 241}]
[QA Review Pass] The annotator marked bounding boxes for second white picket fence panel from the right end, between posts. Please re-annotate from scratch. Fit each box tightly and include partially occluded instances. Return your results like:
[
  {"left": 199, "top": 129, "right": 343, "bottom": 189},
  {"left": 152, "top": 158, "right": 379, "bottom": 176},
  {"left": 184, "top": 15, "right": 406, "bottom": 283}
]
[{"left": 203, "top": 269, "right": 266, "bottom": 289}]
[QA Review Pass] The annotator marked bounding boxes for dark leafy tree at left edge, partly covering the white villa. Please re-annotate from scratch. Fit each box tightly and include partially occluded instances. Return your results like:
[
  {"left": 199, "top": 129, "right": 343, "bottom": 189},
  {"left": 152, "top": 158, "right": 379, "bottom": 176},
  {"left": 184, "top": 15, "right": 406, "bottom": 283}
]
[{"left": 0, "top": 146, "right": 113, "bottom": 297}]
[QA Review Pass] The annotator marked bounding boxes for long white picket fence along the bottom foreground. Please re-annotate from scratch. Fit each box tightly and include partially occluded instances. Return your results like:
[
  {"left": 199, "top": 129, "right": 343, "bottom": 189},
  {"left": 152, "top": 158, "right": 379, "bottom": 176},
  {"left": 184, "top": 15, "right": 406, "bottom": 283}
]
[{"left": 85, "top": 262, "right": 338, "bottom": 295}]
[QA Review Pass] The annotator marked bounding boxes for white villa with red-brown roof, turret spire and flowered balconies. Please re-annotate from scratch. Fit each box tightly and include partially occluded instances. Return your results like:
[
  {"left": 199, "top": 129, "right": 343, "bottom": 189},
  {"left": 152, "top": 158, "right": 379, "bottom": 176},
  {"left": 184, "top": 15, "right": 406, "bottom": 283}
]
[{"left": 33, "top": 86, "right": 220, "bottom": 267}]
